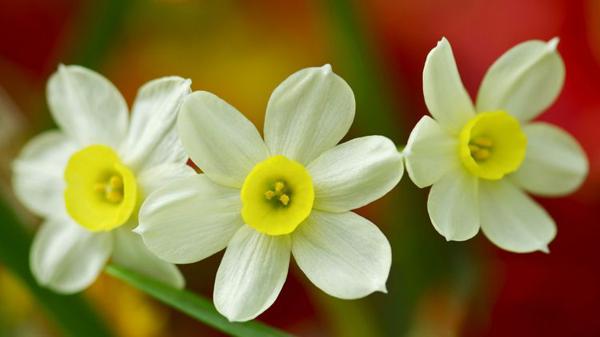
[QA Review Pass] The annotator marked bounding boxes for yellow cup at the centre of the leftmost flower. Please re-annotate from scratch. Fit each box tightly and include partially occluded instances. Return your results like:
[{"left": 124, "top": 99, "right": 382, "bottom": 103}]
[{"left": 64, "top": 145, "right": 138, "bottom": 231}]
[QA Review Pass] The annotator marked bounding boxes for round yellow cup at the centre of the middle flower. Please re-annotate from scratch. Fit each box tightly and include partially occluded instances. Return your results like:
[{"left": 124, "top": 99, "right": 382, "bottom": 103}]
[{"left": 241, "top": 156, "right": 315, "bottom": 235}]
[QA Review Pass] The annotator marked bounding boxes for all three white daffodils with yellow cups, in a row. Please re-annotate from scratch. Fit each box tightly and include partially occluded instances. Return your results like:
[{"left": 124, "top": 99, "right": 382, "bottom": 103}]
[{"left": 13, "top": 39, "right": 588, "bottom": 321}]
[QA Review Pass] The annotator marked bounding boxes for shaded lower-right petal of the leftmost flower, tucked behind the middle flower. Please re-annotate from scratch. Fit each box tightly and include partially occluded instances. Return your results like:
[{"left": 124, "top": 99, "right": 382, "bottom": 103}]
[{"left": 112, "top": 228, "right": 185, "bottom": 289}]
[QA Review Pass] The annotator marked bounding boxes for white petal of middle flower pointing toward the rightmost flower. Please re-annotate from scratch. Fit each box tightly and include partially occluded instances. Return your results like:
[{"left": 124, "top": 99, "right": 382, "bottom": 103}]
[{"left": 308, "top": 136, "right": 403, "bottom": 212}]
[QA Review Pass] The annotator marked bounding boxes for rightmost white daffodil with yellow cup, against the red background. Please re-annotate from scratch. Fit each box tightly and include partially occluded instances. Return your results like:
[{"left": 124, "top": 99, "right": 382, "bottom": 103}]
[{"left": 405, "top": 39, "right": 588, "bottom": 252}]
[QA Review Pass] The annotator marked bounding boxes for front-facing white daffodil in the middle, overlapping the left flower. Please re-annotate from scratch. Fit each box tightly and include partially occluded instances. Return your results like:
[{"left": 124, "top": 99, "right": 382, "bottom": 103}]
[{"left": 136, "top": 65, "right": 403, "bottom": 321}]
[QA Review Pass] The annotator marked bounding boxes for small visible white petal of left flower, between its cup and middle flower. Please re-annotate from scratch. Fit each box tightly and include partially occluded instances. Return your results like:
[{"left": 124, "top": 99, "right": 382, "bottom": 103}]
[{"left": 137, "top": 163, "right": 196, "bottom": 197}]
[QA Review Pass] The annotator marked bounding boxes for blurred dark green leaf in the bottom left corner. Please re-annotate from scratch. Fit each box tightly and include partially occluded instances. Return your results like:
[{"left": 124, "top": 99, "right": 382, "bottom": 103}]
[{"left": 0, "top": 200, "right": 112, "bottom": 337}]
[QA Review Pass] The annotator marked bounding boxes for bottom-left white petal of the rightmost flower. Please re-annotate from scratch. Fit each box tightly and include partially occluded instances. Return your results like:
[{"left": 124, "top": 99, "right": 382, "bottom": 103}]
[{"left": 427, "top": 167, "right": 479, "bottom": 241}]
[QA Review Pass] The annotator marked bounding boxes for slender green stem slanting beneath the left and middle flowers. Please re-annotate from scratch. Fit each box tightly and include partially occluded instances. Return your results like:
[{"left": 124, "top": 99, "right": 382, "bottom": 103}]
[{"left": 106, "top": 265, "right": 291, "bottom": 337}]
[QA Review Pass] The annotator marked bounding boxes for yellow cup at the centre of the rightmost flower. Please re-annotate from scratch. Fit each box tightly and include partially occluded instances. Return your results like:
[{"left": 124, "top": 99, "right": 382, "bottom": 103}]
[{"left": 459, "top": 111, "right": 527, "bottom": 180}]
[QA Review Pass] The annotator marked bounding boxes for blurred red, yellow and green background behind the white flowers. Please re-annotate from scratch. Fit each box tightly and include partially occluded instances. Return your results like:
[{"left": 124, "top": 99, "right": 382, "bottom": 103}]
[{"left": 0, "top": 0, "right": 600, "bottom": 337}]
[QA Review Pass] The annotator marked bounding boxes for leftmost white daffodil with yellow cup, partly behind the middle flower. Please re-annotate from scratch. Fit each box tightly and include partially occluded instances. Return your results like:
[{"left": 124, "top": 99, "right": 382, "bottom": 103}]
[{"left": 13, "top": 66, "right": 194, "bottom": 293}]
